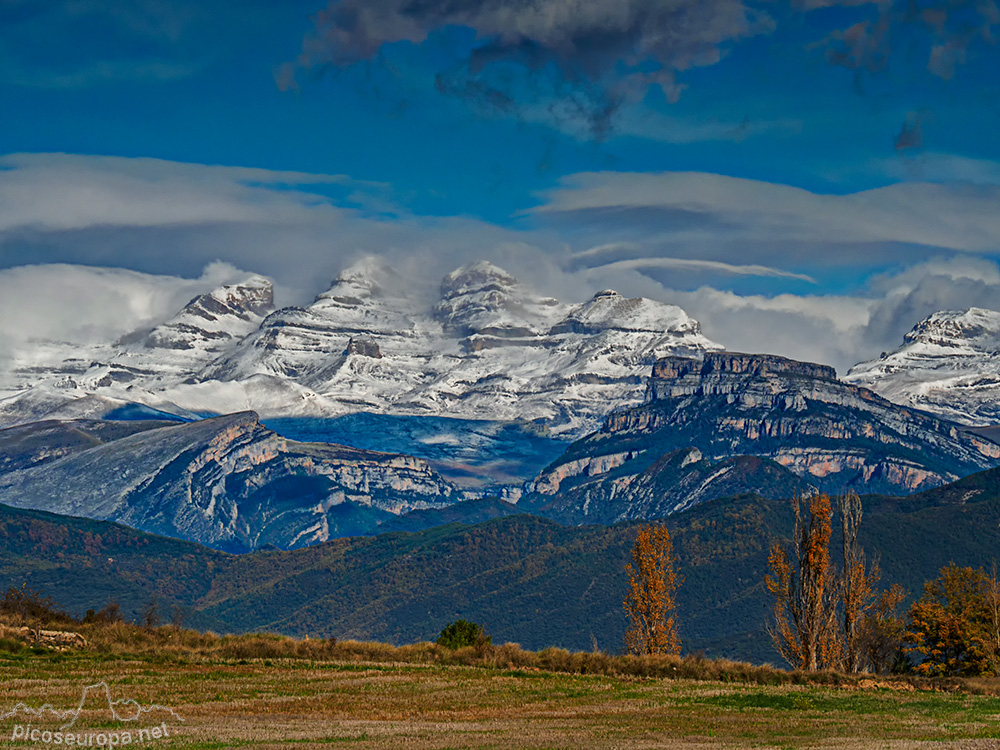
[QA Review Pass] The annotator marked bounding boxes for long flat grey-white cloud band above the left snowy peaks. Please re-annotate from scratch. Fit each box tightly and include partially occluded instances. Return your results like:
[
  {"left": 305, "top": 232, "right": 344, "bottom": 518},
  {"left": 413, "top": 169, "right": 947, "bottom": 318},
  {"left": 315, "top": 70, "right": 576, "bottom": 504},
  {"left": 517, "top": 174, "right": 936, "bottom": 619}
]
[{"left": 0, "top": 154, "right": 538, "bottom": 304}]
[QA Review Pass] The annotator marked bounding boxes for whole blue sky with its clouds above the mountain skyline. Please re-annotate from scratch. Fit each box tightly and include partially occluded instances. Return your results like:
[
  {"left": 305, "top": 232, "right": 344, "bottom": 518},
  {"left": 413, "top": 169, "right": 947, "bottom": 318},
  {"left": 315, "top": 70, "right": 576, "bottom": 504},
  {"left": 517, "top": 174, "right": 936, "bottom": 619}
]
[{"left": 0, "top": 0, "right": 1000, "bottom": 367}]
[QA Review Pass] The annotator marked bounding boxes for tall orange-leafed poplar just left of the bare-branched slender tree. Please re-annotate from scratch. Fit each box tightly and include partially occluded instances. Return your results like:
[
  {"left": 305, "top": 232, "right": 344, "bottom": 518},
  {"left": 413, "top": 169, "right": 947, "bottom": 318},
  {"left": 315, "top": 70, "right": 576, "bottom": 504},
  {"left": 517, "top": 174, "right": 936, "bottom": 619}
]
[{"left": 764, "top": 494, "right": 843, "bottom": 671}]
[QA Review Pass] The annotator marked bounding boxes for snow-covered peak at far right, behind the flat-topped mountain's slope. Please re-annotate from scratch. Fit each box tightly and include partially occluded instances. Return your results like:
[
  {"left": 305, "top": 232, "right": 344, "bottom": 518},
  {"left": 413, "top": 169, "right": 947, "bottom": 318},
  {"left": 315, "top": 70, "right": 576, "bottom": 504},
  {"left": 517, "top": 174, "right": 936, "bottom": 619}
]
[{"left": 844, "top": 307, "right": 1000, "bottom": 425}]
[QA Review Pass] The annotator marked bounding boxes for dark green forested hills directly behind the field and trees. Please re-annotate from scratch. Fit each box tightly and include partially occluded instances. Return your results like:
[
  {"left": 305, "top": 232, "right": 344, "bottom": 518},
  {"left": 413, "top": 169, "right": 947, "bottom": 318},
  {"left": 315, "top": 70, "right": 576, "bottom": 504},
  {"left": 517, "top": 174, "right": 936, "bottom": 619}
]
[{"left": 0, "top": 470, "right": 1000, "bottom": 661}]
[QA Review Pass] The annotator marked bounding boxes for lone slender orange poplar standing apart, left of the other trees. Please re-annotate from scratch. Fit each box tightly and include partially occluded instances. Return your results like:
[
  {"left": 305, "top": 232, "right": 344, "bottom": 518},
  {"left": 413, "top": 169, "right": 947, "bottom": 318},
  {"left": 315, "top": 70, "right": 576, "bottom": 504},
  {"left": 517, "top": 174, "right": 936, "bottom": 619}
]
[{"left": 623, "top": 524, "right": 681, "bottom": 654}]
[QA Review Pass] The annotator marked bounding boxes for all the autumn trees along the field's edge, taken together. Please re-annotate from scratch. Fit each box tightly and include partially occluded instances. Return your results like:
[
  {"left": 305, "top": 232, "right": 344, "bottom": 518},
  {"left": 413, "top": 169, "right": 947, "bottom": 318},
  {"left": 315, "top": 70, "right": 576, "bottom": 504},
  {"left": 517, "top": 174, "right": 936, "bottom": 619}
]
[{"left": 623, "top": 492, "right": 1000, "bottom": 676}]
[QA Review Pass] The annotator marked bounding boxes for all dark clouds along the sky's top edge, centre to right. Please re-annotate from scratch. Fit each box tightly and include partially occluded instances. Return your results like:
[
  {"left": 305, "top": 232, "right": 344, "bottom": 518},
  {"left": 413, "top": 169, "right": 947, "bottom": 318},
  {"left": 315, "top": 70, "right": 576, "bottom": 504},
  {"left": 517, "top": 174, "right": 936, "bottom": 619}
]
[{"left": 286, "top": 0, "right": 1000, "bottom": 138}]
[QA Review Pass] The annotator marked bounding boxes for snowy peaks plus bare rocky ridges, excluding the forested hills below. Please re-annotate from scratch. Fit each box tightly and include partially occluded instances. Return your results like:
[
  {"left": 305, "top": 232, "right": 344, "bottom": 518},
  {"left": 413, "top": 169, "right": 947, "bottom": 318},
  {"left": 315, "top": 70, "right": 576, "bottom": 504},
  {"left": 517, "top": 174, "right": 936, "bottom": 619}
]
[{"left": 0, "top": 259, "right": 1000, "bottom": 551}]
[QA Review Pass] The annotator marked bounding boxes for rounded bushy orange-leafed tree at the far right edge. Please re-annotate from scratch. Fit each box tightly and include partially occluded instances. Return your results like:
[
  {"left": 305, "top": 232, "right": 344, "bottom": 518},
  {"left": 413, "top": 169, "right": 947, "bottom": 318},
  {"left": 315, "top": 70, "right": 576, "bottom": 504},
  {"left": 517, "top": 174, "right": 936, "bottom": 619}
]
[{"left": 906, "top": 563, "right": 1000, "bottom": 676}]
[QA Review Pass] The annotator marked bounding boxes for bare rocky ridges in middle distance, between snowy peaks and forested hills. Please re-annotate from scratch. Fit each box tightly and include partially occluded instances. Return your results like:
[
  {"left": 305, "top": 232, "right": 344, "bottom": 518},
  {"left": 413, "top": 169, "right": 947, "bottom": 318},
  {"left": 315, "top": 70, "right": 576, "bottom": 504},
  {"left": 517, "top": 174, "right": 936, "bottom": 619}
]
[{"left": 0, "top": 351, "right": 1000, "bottom": 551}]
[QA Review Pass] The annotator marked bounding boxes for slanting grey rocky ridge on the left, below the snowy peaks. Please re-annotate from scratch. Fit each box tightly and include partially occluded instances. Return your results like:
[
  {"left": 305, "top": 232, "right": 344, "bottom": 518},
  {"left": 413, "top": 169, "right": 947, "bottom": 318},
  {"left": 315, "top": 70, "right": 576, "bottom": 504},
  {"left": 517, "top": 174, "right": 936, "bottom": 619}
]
[{"left": 0, "top": 412, "right": 459, "bottom": 551}]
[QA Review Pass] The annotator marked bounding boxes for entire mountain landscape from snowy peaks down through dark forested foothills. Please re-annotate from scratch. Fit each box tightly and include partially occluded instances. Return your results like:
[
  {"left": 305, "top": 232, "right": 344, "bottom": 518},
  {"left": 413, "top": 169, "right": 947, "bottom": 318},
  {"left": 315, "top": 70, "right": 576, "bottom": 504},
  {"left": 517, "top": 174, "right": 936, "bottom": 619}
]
[{"left": 0, "top": 260, "right": 1000, "bottom": 660}]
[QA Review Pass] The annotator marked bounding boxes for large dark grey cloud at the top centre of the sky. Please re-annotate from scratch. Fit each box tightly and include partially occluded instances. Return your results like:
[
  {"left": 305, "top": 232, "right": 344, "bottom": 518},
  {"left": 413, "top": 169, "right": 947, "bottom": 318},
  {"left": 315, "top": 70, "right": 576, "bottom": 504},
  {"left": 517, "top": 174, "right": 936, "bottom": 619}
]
[{"left": 286, "top": 0, "right": 773, "bottom": 135}]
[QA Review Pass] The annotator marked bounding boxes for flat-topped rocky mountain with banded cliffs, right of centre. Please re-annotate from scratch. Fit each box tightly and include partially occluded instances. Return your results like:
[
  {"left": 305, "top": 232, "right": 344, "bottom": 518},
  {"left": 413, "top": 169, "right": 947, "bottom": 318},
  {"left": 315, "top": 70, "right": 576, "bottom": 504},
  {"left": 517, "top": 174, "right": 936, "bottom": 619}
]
[{"left": 527, "top": 352, "right": 1000, "bottom": 518}]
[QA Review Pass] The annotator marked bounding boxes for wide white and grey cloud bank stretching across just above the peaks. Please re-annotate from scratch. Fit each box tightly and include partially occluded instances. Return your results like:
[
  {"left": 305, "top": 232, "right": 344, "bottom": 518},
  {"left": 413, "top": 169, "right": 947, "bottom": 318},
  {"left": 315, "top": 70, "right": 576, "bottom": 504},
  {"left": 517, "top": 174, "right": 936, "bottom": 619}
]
[{"left": 0, "top": 154, "right": 1000, "bottom": 371}]
